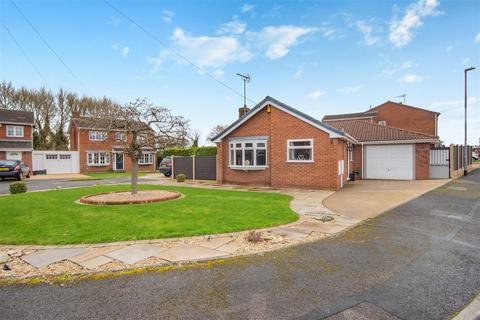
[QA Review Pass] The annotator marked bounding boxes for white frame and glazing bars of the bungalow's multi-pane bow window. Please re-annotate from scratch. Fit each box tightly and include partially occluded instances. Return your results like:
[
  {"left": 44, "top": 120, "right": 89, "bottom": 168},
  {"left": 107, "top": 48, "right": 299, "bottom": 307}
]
[{"left": 228, "top": 139, "right": 268, "bottom": 170}]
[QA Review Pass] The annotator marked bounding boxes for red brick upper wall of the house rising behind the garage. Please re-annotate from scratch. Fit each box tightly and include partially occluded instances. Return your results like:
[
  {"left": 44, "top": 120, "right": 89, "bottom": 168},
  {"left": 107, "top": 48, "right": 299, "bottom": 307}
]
[{"left": 372, "top": 102, "right": 436, "bottom": 135}]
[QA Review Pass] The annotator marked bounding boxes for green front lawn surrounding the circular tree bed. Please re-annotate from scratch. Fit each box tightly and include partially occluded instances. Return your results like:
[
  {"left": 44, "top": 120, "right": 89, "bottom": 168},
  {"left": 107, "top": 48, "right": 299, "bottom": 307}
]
[{"left": 0, "top": 185, "right": 298, "bottom": 244}]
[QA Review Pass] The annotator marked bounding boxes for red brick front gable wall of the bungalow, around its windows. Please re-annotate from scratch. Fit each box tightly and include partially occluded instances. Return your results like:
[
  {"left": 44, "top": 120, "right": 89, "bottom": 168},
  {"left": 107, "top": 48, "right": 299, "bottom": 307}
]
[{"left": 217, "top": 107, "right": 348, "bottom": 190}]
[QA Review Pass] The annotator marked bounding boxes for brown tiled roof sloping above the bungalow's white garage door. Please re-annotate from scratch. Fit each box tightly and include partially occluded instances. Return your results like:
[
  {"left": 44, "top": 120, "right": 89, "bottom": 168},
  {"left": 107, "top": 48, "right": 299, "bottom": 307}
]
[{"left": 329, "top": 120, "right": 438, "bottom": 142}]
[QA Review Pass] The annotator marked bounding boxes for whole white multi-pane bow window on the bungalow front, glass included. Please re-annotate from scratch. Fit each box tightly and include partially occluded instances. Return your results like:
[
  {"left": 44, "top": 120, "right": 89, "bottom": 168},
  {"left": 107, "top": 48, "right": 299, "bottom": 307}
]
[{"left": 229, "top": 140, "right": 267, "bottom": 169}]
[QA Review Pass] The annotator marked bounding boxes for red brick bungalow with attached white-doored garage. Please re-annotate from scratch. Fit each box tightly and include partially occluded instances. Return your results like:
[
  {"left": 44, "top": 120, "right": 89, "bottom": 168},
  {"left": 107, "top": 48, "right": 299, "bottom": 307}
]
[{"left": 212, "top": 97, "right": 439, "bottom": 190}]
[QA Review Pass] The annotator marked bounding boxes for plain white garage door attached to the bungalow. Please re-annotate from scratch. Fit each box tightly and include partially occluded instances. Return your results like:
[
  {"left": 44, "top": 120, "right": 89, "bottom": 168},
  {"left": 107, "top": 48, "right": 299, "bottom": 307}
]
[{"left": 364, "top": 144, "right": 415, "bottom": 180}]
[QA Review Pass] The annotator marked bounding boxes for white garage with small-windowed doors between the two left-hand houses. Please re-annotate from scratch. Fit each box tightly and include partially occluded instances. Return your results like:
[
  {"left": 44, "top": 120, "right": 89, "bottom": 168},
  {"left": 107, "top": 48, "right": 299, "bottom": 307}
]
[{"left": 32, "top": 151, "right": 80, "bottom": 174}]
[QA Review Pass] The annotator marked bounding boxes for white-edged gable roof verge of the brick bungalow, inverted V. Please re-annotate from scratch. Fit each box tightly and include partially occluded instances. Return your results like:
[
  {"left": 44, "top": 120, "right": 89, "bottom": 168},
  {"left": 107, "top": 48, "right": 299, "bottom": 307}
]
[{"left": 212, "top": 96, "right": 350, "bottom": 142}]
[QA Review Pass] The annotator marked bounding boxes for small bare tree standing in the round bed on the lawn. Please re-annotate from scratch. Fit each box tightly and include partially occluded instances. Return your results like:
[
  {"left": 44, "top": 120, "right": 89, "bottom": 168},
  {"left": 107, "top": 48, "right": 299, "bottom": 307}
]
[{"left": 97, "top": 99, "right": 189, "bottom": 194}]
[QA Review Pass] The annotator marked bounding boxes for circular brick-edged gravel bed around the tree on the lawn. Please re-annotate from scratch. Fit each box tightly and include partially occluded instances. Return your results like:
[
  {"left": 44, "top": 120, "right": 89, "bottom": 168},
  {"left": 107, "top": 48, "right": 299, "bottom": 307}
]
[{"left": 80, "top": 190, "right": 182, "bottom": 205}]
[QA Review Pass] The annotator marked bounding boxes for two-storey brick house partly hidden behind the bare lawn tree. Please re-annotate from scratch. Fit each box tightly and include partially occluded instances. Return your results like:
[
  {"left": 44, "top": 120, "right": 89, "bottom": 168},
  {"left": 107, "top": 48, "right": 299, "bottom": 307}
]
[{"left": 69, "top": 112, "right": 156, "bottom": 172}]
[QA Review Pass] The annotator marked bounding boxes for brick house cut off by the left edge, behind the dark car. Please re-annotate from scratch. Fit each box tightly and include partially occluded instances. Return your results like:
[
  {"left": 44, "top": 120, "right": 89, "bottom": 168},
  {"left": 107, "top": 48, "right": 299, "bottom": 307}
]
[{"left": 0, "top": 109, "right": 34, "bottom": 169}]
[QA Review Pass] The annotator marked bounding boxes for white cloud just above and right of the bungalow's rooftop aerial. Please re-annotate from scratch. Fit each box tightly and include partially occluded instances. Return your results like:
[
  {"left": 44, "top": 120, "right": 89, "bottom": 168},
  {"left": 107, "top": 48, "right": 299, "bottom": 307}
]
[{"left": 247, "top": 26, "right": 317, "bottom": 59}]
